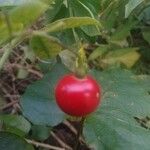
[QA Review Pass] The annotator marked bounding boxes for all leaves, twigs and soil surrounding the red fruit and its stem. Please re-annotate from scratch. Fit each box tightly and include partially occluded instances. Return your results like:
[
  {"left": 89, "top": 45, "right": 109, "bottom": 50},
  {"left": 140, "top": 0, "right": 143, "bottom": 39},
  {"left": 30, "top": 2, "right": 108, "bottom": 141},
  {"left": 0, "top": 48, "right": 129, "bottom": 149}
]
[{"left": 0, "top": 0, "right": 150, "bottom": 150}]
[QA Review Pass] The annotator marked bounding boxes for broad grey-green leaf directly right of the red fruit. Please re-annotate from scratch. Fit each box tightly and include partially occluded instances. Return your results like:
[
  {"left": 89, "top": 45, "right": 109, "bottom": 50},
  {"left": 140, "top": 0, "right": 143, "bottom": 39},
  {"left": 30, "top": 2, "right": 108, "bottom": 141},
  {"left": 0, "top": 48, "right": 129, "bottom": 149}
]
[{"left": 93, "top": 69, "right": 150, "bottom": 117}]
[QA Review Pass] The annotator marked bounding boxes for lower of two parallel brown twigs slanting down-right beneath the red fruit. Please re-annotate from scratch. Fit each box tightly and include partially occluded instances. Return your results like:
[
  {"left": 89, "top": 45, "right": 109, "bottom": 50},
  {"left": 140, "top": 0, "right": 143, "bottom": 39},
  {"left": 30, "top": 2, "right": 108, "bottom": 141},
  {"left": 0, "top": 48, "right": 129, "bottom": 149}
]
[{"left": 51, "top": 132, "right": 73, "bottom": 150}]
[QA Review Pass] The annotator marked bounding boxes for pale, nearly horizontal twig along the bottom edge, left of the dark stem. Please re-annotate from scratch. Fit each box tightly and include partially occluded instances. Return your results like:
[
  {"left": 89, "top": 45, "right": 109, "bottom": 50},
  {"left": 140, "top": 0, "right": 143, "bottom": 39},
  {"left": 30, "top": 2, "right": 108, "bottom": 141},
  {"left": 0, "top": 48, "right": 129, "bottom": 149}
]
[{"left": 26, "top": 139, "right": 65, "bottom": 150}]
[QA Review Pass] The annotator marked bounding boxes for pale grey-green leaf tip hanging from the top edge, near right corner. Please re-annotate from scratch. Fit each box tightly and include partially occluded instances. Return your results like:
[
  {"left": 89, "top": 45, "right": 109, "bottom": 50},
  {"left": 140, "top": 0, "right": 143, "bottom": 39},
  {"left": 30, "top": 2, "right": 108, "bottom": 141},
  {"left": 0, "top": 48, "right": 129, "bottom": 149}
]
[{"left": 125, "top": 0, "right": 144, "bottom": 18}]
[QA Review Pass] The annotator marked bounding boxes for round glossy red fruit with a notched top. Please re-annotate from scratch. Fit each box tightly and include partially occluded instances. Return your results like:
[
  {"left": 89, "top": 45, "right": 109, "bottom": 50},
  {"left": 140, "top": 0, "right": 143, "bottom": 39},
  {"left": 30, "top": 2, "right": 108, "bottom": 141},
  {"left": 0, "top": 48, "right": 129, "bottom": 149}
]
[{"left": 55, "top": 74, "right": 101, "bottom": 117}]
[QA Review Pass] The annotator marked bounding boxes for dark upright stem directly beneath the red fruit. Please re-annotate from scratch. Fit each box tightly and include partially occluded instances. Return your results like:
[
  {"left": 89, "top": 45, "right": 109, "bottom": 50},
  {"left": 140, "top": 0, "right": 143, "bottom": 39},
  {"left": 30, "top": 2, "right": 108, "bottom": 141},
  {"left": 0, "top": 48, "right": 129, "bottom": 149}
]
[{"left": 74, "top": 117, "right": 86, "bottom": 150}]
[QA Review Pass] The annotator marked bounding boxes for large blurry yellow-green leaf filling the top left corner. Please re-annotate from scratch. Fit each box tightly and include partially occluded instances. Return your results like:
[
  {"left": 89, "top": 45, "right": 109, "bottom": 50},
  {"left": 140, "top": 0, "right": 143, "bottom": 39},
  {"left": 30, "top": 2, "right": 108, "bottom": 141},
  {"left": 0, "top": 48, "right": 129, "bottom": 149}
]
[{"left": 0, "top": 0, "right": 48, "bottom": 44}]
